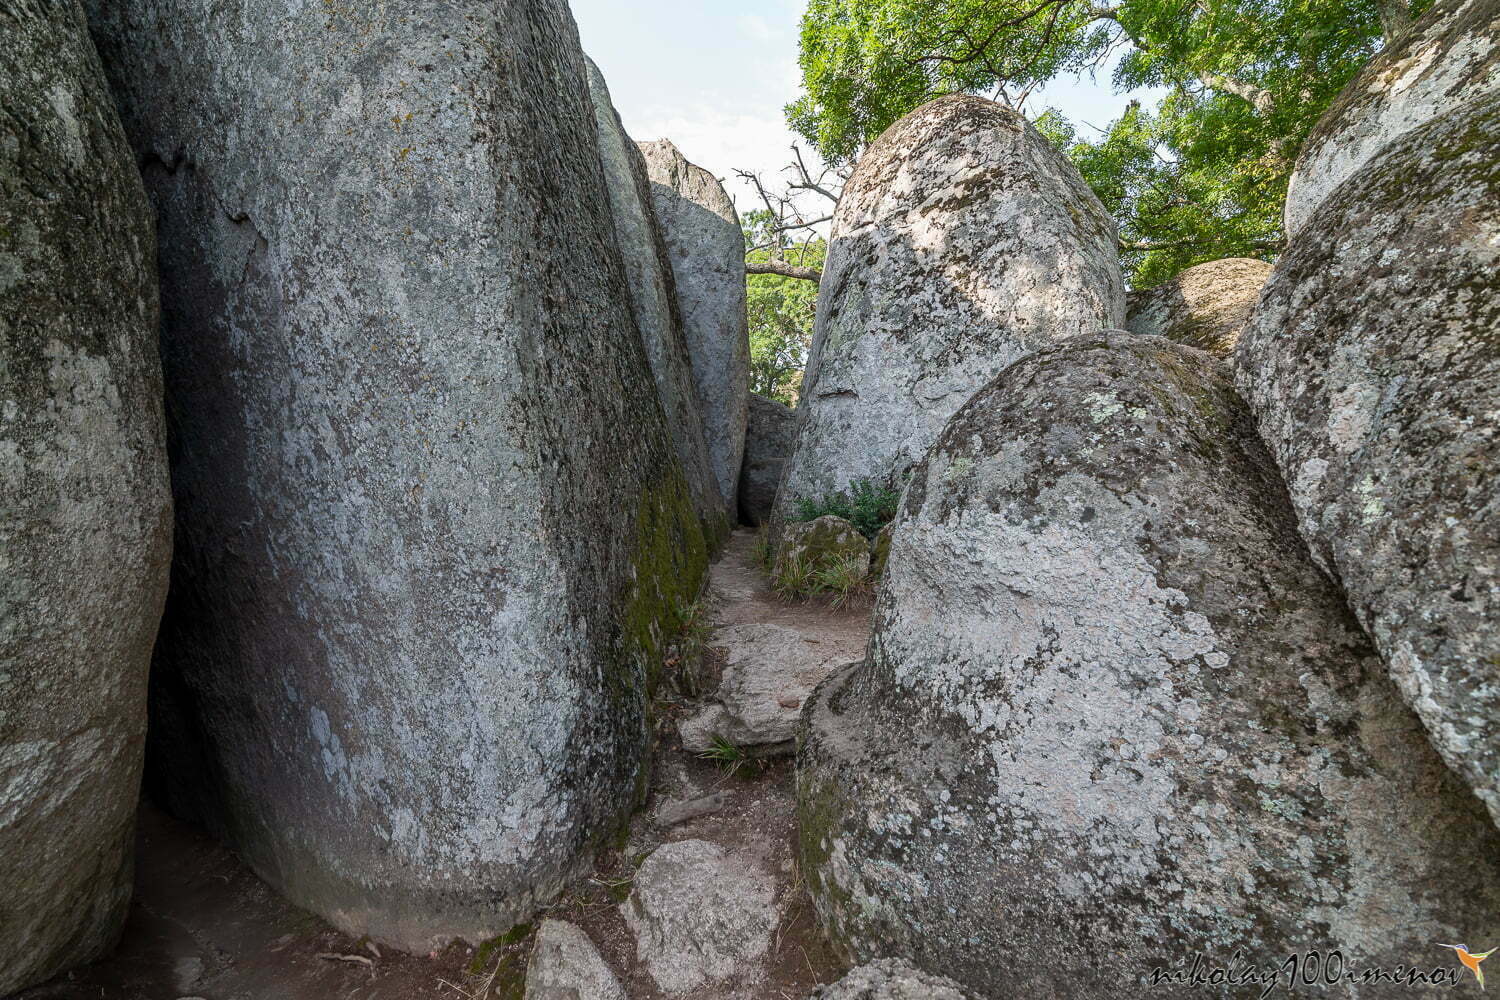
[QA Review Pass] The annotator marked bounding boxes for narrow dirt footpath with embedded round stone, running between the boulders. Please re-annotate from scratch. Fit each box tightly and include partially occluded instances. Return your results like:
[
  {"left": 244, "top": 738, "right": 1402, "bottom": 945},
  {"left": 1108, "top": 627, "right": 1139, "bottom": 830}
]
[{"left": 549, "top": 529, "right": 870, "bottom": 1000}]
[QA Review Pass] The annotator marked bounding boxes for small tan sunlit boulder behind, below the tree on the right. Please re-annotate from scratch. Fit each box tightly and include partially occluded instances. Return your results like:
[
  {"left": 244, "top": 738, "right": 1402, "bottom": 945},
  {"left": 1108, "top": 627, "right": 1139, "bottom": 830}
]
[{"left": 1125, "top": 256, "right": 1271, "bottom": 358}]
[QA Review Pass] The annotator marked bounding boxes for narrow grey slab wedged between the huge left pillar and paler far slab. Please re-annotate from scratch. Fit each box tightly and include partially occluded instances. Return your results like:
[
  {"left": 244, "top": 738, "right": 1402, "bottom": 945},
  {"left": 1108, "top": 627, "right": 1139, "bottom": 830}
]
[{"left": 587, "top": 60, "right": 734, "bottom": 546}]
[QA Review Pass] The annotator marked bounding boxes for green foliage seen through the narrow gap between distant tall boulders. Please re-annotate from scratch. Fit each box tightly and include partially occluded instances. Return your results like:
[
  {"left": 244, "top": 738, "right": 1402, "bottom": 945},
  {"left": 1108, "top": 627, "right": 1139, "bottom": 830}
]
[{"left": 744, "top": 210, "right": 828, "bottom": 406}]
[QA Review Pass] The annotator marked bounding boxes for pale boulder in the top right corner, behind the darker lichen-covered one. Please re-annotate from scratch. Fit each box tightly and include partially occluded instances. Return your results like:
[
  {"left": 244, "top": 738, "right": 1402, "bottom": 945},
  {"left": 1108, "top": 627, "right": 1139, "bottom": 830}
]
[{"left": 1284, "top": 0, "right": 1500, "bottom": 237}]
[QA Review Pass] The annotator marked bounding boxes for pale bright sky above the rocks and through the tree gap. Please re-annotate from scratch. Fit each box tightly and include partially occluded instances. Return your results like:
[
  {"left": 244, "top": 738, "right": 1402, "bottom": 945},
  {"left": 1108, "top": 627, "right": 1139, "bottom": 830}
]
[{"left": 572, "top": 0, "right": 1149, "bottom": 224}]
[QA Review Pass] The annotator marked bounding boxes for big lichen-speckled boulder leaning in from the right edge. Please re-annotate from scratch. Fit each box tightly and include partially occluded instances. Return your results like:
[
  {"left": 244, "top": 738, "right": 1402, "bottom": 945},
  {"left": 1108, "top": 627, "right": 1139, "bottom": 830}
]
[{"left": 1236, "top": 91, "right": 1500, "bottom": 822}]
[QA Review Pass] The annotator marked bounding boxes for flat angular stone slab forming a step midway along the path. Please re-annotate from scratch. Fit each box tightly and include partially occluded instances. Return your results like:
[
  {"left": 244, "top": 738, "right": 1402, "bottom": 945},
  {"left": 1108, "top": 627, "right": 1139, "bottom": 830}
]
[{"left": 680, "top": 625, "right": 843, "bottom": 753}]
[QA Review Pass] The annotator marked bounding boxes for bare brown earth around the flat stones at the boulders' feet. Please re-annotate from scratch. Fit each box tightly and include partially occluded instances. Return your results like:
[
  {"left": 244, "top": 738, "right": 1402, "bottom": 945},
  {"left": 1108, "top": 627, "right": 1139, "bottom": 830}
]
[{"left": 17, "top": 531, "right": 869, "bottom": 1000}]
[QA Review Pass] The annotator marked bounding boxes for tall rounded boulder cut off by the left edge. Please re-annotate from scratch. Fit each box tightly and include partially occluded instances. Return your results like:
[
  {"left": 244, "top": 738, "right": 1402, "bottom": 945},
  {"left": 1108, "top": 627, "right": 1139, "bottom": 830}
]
[{"left": 0, "top": 0, "right": 171, "bottom": 996}]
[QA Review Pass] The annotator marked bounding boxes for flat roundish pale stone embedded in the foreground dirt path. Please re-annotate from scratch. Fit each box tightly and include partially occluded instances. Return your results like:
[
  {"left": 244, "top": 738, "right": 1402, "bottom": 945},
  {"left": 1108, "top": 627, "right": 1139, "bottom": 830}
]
[{"left": 620, "top": 840, "right": 777, "bottom": 994}]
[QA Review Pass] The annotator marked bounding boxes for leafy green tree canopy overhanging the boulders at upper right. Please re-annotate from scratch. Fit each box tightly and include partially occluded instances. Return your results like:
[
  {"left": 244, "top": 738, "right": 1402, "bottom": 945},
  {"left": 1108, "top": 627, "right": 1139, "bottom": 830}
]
[{"left": 788, "top": 0, "right": 1428, "bottom": 288}]
